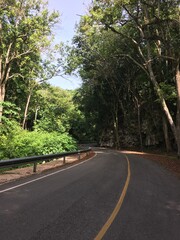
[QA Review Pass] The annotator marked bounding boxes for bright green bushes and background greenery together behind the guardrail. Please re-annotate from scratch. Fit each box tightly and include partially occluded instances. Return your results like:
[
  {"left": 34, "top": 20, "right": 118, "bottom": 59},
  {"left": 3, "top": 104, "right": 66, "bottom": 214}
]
[{"left": 0, "top": 87, "right": 77, "bottom": 159}]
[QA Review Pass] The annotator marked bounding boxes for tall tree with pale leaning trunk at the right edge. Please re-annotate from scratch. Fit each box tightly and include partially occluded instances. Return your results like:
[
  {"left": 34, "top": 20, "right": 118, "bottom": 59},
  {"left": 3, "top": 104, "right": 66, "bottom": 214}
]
[{"left": 80, "top": 0, "right": 180, "bottom": 156}]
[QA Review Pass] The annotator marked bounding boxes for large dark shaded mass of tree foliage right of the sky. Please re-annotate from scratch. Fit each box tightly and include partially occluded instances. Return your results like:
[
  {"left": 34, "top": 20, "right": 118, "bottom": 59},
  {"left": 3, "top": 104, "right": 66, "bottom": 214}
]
[{"left": 68, "top": 0, "right": 179, "bottom": 150}]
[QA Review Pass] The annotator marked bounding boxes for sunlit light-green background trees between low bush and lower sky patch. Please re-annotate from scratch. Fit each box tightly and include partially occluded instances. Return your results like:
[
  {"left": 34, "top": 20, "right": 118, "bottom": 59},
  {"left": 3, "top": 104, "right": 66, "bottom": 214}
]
[{"left": 34, "top": 84, "right": 75, "bottom": 133}]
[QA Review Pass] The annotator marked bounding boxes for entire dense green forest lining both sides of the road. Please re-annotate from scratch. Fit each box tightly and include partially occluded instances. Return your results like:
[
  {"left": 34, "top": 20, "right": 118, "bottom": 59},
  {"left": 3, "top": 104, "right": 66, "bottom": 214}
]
[{"left": 0, "top": 0, "right": 180, "bottom": 159}]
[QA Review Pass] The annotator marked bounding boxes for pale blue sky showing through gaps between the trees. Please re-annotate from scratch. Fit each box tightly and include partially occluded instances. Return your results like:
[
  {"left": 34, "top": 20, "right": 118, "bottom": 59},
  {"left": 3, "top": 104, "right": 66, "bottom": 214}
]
[{"left": 48, "top": 0, "right": 91, "bottom": 89}]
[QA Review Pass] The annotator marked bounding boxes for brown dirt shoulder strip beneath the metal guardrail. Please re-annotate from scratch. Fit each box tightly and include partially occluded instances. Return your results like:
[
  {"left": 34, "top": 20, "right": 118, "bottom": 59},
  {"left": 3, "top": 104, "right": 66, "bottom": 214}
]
[{"left": 0, "top": 152, "right": 95, "bottom": 185}]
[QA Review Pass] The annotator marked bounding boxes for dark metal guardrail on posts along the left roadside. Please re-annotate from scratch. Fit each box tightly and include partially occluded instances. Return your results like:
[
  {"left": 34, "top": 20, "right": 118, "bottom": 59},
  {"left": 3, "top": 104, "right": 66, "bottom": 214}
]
[{"left": 0, "top": 148, "right": 92, "bottom": 172}]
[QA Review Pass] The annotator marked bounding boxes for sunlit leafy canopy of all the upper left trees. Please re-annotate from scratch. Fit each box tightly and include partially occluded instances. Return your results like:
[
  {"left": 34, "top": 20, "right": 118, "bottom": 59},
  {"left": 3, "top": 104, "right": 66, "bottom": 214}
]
[{"left": 0, "top": 0, "right": 62, "bottom": 130}]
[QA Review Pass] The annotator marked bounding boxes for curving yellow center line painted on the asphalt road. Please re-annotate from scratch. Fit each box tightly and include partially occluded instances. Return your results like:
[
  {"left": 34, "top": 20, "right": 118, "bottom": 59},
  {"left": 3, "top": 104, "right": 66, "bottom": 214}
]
[{"left": 94, "top": 155, "right": 131, "bottom": 240}]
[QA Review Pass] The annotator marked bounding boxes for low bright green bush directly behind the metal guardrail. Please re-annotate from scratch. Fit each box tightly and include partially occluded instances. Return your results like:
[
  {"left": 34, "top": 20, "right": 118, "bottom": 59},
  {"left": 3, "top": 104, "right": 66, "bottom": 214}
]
[{"left": 0, "top": 129, "right": 76, "bottom": 159}]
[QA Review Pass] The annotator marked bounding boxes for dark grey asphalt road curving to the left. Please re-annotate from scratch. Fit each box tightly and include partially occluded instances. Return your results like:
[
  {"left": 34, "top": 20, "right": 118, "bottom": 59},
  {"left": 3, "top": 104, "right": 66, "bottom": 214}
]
[{"left": 0, "top": 150, "right": 180, "bottom": 240}]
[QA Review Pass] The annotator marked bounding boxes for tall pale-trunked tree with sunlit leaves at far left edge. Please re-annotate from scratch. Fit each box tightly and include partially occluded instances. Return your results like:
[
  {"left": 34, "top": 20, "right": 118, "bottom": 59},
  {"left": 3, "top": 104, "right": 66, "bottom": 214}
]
[{"left": 0, "top": 0, "right": 59, "bottom": 122}]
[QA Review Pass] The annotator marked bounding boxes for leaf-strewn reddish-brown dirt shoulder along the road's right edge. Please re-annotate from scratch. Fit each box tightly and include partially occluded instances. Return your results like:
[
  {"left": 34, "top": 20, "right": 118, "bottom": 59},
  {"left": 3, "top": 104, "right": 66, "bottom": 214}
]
[{"left": 121, "top": 150, "right": 180, "bottom": 178}]
